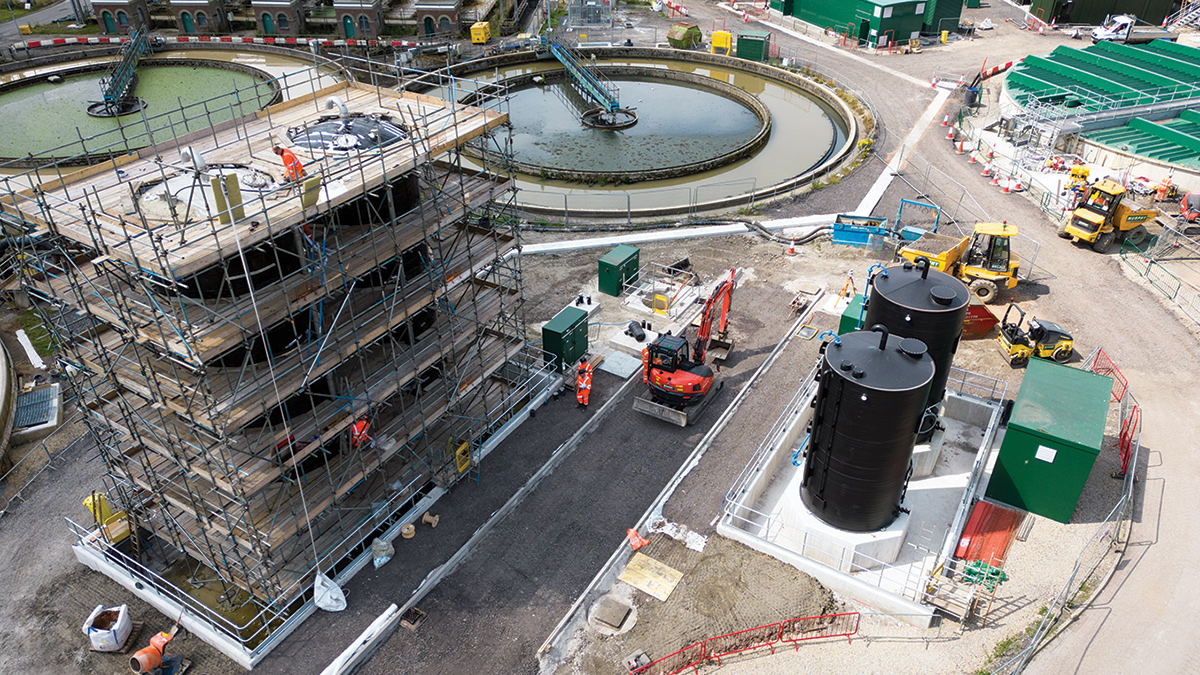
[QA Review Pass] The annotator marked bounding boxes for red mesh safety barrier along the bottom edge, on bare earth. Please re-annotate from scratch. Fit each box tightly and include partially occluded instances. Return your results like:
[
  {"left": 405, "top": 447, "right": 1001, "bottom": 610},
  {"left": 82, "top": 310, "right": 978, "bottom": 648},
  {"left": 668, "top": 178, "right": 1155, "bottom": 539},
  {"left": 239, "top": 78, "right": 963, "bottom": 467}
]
[{"left": 634, "top": 611, "right": 860, "bottom": 675}]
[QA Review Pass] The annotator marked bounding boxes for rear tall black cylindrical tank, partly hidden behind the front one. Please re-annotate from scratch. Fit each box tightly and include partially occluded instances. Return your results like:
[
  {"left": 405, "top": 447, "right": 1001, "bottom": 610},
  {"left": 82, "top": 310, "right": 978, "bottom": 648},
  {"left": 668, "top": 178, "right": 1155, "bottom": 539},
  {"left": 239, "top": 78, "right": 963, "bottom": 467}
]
[{"left": 863, "top": 257, "right": 971, "bottom": 407}]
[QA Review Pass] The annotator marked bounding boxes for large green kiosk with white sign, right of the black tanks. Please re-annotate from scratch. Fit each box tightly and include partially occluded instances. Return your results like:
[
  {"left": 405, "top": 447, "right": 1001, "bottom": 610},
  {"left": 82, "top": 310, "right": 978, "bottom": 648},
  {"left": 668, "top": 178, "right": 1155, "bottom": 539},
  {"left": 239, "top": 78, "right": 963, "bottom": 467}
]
[{"left": 986, "top": 359, "right": 1112, "bottom": 522}]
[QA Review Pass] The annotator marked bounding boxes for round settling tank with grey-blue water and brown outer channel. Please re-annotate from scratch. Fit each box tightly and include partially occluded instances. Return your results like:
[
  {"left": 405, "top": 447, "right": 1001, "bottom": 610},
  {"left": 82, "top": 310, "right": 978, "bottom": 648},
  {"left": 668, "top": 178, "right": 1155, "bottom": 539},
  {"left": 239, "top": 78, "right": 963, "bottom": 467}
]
[{"left": 424, "top": 48, "right": 864, "bottom": 219}]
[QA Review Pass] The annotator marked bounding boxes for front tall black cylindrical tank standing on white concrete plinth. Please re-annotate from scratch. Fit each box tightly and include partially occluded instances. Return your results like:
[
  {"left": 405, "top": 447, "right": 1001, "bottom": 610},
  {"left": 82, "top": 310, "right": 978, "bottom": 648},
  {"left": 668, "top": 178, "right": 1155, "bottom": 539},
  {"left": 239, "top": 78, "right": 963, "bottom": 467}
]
[{"left": 800, "top": 325, "right": 935, "bottom": 532}]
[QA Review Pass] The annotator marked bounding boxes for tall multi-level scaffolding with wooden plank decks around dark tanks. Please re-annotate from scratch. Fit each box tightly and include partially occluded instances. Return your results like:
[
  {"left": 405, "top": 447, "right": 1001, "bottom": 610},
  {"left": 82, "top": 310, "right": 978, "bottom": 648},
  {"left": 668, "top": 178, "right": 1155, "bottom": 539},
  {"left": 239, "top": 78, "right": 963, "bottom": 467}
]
[{"left": 0, "top": 52, "right": 547, "bottom": 650}]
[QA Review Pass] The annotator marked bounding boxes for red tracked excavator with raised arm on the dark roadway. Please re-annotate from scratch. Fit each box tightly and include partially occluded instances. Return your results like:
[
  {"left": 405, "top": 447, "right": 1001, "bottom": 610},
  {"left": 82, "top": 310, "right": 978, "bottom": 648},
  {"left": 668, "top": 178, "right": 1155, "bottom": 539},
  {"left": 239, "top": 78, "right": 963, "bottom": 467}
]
[{"left": 634, "top": 269, "right": 734, "bottom": 426}]
